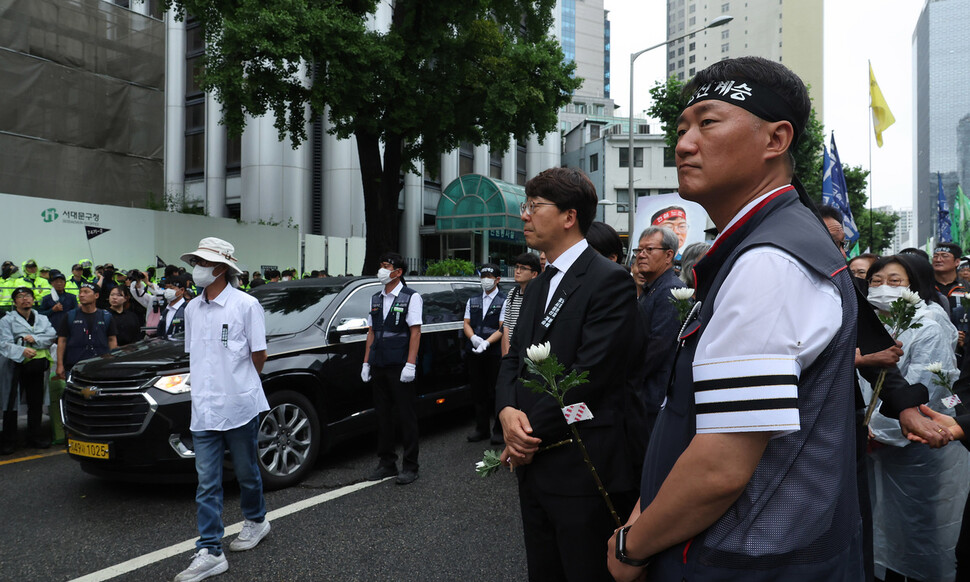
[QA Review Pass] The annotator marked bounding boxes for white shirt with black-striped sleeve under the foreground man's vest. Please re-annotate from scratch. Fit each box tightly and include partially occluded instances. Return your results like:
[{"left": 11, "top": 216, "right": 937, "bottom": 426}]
[{"left": 693, "top": 191, "right": 842, "bottom": 437}]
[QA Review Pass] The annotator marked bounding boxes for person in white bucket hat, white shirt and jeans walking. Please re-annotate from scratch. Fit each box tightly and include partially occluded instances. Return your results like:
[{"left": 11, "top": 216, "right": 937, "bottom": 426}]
[{"left": 175, "top": 237, "right": 270, "bottom": 582}]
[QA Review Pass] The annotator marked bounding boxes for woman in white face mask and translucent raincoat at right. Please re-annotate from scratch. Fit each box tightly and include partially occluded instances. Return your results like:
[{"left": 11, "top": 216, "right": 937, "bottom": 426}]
[{"left": 860, "top": 256, "right": 970, "bottom": 580}]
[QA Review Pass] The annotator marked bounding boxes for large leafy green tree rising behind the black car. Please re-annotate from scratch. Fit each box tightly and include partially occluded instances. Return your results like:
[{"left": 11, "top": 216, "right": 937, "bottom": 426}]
[{"left": 166, "top": 0, "right": 582, "bottom": 273}]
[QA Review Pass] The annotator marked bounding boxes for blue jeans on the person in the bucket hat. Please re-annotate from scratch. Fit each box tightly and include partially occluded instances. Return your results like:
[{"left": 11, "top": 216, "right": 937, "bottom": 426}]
[{"left": 192, "top": 416, "right": 266, "bottom": 555}]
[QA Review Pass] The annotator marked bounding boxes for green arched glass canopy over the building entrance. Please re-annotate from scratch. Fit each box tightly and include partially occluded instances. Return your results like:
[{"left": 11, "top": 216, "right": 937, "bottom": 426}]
[{"left": 435, "top": 174, "right": 525, "bottom": 232}]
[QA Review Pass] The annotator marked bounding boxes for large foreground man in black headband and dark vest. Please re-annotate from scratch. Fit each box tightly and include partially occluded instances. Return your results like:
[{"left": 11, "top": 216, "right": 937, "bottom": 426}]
[{"left": 608, "top": 57, "right": 864, "bottom": 582}]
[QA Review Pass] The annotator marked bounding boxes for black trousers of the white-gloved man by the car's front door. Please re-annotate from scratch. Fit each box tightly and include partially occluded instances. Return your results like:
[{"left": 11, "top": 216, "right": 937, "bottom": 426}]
[{"left": 371, "top": 365, "right": 418, "bottom": 473}]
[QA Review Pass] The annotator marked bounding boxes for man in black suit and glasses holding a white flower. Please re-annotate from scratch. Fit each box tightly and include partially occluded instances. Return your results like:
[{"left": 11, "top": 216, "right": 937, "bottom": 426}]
[{"left": 496, "top": 168, "right": 638, "bottom": 582}]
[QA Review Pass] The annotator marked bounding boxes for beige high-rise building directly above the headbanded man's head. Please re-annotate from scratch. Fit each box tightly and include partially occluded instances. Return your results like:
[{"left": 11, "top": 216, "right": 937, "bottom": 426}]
[{"left": 667, "top": 0, "right": 823, "bottom": 120}]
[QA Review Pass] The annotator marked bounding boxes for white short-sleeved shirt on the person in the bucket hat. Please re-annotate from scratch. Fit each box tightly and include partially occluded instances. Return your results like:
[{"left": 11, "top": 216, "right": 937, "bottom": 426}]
[{"left": 185, "top": 285, "right": 269, "bottom": 431}]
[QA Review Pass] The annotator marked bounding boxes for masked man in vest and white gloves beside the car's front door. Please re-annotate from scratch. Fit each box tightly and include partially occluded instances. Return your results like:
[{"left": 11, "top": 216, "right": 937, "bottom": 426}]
[{"left": 360, "top": 253, "right": 424, "bottom": 485}]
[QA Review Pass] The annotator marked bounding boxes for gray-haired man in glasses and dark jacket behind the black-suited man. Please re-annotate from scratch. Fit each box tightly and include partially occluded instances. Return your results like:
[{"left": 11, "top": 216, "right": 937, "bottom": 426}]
[{"left": 634, "top": 226, "right": 684, "bottom": 438}]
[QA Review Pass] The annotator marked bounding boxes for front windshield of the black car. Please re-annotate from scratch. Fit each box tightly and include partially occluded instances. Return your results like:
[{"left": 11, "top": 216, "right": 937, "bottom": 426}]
[{"left": 252, "top": 284, "right": 343, "bottom": 336}]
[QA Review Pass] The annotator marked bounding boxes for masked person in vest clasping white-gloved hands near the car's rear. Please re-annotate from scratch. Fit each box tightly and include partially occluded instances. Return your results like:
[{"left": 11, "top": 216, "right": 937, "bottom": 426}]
[{"left": 464, "top": 263, "right": 505, "bottom": 444}]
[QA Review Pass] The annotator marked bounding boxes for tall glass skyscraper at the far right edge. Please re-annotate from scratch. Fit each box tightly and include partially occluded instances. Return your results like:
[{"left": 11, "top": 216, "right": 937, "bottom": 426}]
[{"left": 913, "top": 0, "right": 970, "bottom": 244}]
